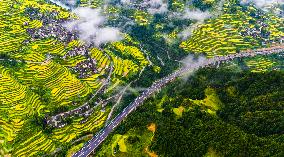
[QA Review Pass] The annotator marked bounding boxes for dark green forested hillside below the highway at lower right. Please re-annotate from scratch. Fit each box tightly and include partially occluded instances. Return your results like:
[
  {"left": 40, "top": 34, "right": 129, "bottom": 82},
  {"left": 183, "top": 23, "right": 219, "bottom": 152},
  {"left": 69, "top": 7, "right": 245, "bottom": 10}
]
[{"left": 96, "top": 68, "right": 284, "bottom": 156}]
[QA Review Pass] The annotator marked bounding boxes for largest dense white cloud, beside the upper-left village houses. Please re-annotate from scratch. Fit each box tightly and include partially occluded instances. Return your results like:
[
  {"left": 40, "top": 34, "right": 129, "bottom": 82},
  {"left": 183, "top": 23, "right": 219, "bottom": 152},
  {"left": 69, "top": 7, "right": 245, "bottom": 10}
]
[{"left": 65, "top": 7, "right": 122, "bottom": 46}]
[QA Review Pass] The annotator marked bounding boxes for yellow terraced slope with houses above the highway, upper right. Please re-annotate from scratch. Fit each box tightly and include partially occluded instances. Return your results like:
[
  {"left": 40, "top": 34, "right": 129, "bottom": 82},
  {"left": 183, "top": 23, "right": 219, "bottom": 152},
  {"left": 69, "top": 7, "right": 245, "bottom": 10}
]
[{"left": 180, "top": 3, "right": 284, "bottom": 57}]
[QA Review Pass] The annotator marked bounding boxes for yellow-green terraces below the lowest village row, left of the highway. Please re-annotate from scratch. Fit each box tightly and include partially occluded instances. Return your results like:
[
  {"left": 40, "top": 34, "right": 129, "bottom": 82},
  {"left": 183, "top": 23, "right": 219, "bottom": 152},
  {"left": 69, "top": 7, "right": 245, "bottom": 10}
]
[{"left": 13, "top": 106, "right": 107, "bottom": 156}]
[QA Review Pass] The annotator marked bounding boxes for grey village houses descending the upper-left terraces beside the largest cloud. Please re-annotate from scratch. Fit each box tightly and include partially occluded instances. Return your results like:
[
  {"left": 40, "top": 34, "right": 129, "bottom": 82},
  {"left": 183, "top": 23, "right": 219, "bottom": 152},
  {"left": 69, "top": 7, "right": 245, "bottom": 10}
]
[{"left": 25, "top": 8, "right": 102, "bottom": 78}]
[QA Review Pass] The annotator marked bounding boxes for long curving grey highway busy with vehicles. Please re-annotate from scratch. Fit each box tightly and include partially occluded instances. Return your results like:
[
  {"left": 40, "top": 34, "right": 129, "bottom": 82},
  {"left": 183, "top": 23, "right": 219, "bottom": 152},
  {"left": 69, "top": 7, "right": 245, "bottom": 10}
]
[{"left": 73, "top": 46, "right": 284, "bottom": 157}]
